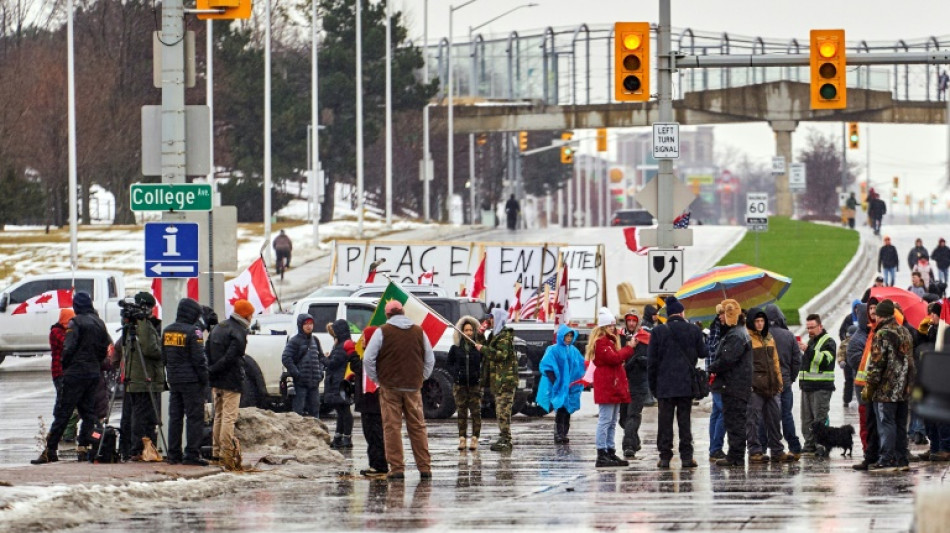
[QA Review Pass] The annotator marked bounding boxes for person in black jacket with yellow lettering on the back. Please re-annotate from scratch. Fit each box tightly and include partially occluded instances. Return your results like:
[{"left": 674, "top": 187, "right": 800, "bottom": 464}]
[{"left": 162, "top": 298, "right": 208, "bottom": 466}]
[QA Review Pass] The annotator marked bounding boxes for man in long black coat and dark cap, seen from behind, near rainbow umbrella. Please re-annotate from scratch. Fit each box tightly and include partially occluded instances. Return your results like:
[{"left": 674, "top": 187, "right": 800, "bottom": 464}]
[{"left": 647, "top": 296, "right": 706, "bottom": 468}]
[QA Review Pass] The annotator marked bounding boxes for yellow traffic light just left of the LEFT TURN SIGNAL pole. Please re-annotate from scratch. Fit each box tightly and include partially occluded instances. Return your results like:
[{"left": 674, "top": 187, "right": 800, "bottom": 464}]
[{"left": 614, "top": 22, "right": 650, "bottom": 102}]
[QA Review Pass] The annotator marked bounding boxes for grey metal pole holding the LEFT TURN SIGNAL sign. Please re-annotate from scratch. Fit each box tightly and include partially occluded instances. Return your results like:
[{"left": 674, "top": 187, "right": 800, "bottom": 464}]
[{"left": 656, "top": 0, "right": 676, "bottom": 249}]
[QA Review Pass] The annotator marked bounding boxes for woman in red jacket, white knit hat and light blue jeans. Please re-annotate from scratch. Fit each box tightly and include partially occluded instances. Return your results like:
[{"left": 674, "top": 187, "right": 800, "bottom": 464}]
[{"left": 587, "top": 307, "right": 633, "bottom": 467}]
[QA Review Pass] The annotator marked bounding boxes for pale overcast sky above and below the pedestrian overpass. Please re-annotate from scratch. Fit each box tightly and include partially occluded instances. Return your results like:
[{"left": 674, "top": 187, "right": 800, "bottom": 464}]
[{"left": 393, "top": 0, "right": 950, "bottom": 206}]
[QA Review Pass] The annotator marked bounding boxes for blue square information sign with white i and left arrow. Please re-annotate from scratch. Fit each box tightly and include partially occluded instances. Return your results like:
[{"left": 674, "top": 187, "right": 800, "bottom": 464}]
[{"left": 145, "top": 222, "right": 198, "bottom": 278}]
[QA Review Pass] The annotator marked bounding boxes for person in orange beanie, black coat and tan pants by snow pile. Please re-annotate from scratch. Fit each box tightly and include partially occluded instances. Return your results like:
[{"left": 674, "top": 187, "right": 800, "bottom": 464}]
[{"left": 205, "top": 300, "right": 254, "bottom": 468}]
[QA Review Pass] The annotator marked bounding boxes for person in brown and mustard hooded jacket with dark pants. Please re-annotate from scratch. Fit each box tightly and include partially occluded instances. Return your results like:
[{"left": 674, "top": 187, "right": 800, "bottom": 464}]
[{"left": 746, "top": 307, "right": 794, "bottom": 463}]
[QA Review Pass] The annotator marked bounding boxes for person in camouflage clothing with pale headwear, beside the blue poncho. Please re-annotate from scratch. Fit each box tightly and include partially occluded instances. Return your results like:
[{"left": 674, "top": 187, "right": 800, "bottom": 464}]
[{"left": 475, "top": 307, "right": 518, "bottom": 452}]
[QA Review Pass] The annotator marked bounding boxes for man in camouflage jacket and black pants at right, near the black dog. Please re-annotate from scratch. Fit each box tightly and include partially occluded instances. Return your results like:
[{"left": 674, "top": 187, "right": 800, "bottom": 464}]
[{"left": 862, "top": 300, "right": 915, "bottom": 470}]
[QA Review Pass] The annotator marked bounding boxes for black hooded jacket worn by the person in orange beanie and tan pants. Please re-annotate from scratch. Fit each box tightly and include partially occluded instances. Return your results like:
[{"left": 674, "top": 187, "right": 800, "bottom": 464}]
[{"left": 205, "top": 313, "right": 249, "bottom": 392}]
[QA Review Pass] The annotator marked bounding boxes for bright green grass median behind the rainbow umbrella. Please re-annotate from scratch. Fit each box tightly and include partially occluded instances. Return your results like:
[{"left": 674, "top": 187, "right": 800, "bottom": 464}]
[{"left": 719, "top": 217, "right": 860, "bottom": 324}]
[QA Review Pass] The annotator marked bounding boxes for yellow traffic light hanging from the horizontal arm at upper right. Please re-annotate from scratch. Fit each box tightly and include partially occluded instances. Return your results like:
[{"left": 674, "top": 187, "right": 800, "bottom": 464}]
[{"left": 808, "top": 30, "right": 848, "bottom": 109}]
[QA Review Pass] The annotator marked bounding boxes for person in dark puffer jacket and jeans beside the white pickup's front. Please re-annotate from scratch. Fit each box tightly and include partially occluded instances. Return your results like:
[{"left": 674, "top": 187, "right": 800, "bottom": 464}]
[{"left": 281, "top": 313, "right": 324, "bottom": 418}]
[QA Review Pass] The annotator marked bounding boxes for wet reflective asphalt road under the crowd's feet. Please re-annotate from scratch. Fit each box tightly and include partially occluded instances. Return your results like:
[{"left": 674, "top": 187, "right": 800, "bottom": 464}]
[{"left": 0, "top": 359, "right": 947, "bottom": 532}]
